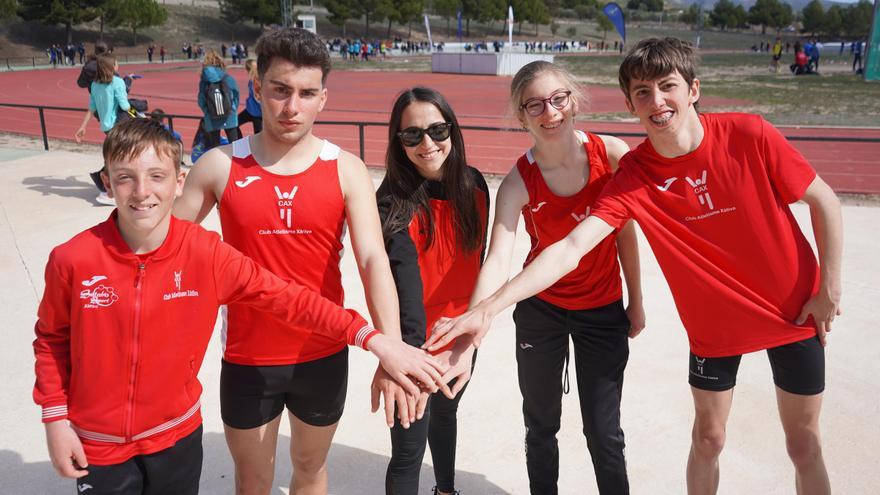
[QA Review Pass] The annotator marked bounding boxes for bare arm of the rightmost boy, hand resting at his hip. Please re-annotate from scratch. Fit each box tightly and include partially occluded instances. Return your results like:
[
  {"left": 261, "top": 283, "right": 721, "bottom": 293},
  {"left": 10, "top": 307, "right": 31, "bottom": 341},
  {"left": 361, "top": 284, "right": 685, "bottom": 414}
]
[{"left": 795, "top": 176, "right": 843, "bottom": 346}]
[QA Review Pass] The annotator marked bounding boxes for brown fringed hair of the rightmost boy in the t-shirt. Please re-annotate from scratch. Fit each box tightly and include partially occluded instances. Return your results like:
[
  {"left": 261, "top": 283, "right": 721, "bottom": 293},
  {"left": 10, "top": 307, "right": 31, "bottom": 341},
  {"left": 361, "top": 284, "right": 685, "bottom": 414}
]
[{"left": 617, "top": 38, "right": 697, "bottom": 100}]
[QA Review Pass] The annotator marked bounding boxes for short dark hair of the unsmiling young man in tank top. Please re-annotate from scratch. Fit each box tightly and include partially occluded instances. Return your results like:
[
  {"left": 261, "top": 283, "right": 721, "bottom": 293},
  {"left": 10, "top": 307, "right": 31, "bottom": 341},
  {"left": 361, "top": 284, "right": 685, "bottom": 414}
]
[{"left": 255, "top": 27, "right": 330, "bottom": 85}]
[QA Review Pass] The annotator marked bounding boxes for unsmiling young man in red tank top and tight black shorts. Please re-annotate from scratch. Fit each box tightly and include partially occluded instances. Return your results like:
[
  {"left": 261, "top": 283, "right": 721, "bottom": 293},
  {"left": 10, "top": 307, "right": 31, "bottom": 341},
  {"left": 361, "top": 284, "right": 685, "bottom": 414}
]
[{"left": 174, "top": 29, "right": 440, "bottom": 494}]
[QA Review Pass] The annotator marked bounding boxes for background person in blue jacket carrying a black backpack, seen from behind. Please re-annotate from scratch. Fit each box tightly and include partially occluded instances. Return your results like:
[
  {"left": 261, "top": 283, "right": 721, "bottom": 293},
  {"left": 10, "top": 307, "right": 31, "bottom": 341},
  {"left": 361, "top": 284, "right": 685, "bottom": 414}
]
[{"left": 198, "top": 50, "right": 241, "bottom": 149}]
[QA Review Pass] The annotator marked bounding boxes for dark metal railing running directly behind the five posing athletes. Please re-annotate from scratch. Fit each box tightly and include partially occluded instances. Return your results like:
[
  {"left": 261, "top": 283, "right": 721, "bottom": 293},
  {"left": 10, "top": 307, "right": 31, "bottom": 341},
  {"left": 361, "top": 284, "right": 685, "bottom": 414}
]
[{"left": 0, "top": 102, "right": 880, "bottom": 160}]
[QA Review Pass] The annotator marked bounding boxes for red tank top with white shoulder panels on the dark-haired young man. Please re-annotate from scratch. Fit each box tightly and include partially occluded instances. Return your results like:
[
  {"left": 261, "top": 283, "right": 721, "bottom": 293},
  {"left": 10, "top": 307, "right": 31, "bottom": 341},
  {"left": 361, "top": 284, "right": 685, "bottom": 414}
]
[{"left": 219, "top": 138, "right": 345, "bottom": 366}]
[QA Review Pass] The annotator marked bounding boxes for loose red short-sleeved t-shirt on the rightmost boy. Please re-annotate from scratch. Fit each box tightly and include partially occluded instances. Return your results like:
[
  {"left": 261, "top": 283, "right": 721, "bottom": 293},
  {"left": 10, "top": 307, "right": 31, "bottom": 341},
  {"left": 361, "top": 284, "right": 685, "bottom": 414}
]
[{"left": 592, "top": 113, "right": 819, "bottom": 357}]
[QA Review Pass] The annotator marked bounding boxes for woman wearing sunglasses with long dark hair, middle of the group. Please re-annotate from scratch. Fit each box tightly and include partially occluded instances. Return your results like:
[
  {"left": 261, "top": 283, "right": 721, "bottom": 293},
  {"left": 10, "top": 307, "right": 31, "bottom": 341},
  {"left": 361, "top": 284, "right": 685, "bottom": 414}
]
[{"left": 374, "top": 87, "right": 489, "bottom": 495}]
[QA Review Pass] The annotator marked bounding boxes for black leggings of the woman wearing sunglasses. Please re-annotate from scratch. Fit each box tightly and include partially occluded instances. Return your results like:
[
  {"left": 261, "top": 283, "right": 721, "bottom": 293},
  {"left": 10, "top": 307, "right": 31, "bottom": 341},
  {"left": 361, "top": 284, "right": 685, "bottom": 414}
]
[{"left": 385, "top": 353, "right": 477, "bottom": 495}]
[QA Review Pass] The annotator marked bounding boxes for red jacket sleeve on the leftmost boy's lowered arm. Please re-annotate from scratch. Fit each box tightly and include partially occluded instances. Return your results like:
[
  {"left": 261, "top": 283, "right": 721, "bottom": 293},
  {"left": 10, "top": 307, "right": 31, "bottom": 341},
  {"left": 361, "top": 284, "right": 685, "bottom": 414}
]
[{"left": 33, "top": 250, "right": 71, "bottom": 423}]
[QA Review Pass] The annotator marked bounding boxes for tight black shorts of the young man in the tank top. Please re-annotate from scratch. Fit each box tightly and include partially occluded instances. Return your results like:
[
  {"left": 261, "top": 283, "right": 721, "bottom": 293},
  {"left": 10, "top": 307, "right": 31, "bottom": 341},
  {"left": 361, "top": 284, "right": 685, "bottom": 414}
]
[{"left": 220, "top": 347, "right": 348, "bottom": 430}]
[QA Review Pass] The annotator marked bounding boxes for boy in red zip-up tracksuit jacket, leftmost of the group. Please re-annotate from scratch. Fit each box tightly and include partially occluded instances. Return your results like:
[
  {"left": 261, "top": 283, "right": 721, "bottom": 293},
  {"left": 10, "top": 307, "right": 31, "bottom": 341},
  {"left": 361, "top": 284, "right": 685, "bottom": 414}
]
[{"left": 34, "top": 119, "right": 442, "bottom": 495}]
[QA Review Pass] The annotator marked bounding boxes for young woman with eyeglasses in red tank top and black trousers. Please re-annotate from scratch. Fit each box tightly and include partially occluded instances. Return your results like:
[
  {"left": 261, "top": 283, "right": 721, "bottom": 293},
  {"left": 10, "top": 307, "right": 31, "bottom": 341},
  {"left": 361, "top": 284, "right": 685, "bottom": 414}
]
[{"left": 458, "top": 61, "right": 645, "bottom": 495}]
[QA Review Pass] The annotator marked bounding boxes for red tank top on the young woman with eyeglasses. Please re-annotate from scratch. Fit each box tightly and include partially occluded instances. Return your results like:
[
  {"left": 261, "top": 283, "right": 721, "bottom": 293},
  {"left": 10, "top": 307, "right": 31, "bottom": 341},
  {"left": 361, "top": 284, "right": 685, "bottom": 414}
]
[{"left": 516, "top": 131, "right": 623, "bottom": 310}]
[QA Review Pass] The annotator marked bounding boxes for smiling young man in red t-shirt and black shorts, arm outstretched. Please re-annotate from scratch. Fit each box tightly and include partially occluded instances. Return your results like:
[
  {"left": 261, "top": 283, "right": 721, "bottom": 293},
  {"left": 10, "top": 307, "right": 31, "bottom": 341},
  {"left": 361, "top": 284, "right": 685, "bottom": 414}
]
[{"left": 426, "top": 38, "right": 843, "bottom": 494}]
